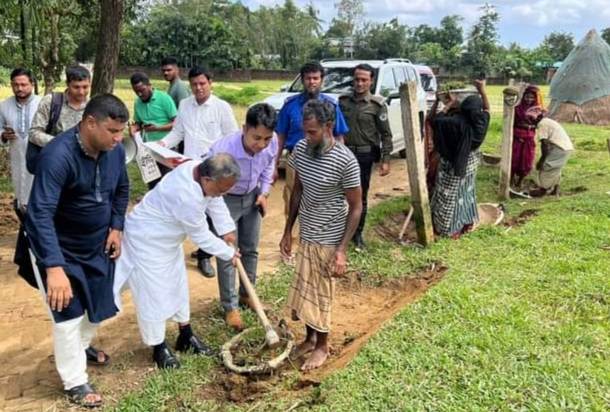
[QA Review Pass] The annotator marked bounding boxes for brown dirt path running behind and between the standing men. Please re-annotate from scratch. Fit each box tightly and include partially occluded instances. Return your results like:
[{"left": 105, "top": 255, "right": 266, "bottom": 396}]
[{"left": 0, "top": 159, "right": 407, "bottom": 411}]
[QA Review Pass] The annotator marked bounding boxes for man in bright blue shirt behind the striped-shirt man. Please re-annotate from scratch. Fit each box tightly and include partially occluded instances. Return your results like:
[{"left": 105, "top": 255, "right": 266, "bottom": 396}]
[{"left": 275, "top": 62, "right": 349, "bottom": 251}]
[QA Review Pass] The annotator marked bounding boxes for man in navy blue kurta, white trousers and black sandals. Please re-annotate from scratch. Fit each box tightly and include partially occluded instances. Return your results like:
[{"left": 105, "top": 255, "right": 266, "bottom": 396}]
[{"left": 25, "top": 95, "right": 129, "bottom": 406}]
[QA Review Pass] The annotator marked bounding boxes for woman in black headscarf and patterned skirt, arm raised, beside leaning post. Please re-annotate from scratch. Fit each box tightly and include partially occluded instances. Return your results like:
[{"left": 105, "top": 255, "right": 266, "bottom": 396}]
[{"left": 430, "top": 80, "right": 490, "bottom": 239}]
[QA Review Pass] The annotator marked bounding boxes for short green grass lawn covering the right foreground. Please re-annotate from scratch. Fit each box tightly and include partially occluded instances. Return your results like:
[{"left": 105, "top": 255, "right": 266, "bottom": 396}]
[{"left": 2, "top": 79, "right": 610, "bottom": 411}]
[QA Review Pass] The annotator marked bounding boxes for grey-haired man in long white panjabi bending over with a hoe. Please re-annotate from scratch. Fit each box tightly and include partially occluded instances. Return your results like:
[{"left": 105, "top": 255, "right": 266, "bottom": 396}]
[{"left": 114, "top": 153, "right": 240, "bottom": 369}]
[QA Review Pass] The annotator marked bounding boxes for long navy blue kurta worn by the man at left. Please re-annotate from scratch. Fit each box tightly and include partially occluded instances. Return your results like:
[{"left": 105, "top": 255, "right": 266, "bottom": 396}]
[{"left": 25, "top": 126, "right": 129, "bottom": 323}]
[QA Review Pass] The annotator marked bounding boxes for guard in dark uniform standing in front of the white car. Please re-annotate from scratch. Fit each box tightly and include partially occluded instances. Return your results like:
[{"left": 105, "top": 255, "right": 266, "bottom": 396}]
[{"left": 339, "top": 64, "right": 392, "bottom": 250}]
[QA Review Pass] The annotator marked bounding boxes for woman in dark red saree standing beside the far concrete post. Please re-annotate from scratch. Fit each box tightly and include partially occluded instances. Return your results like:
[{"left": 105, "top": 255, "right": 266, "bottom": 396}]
[{"left": 511, "top": 85, "right": 542, "bottom": 190}]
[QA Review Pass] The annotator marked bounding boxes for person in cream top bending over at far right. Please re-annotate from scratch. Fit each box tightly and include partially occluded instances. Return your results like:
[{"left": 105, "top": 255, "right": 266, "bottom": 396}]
[{"left": 527, "top": 106, "right": 574, "bottom": 197}]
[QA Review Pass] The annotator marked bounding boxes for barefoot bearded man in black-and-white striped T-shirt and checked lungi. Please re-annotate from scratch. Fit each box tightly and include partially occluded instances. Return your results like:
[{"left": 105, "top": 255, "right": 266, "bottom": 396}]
[{"left": 280, "top": 100, "right": 362, "bottom": 371}]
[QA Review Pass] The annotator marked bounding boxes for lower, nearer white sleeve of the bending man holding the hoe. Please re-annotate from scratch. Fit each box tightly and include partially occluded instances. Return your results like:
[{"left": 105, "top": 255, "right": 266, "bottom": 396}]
[{"left": 180, "top": 206, "right": 235, "bottom": 260}]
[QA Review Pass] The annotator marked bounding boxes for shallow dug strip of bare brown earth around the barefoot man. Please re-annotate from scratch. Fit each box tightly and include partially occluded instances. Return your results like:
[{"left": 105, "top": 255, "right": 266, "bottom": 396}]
[{"left": 199, "top": 264, "right": 447, "bottom": 403}]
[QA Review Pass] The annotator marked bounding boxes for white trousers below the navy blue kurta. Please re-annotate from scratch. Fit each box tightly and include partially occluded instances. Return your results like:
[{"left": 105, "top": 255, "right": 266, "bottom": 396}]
[{"left": 53, "top": 314, "right": 99, "bottom": 389}]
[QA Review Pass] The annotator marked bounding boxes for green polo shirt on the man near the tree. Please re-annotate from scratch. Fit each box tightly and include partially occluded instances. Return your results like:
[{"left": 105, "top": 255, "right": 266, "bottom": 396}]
[{"left": 134, "top": 90, "right": 178, "bottom": 142}]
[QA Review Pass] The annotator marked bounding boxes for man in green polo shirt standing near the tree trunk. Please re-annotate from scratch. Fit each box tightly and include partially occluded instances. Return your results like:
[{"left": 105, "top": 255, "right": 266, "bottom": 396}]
[{"left": 131, "top": 73, "right": 178, "bottom": 142}]
